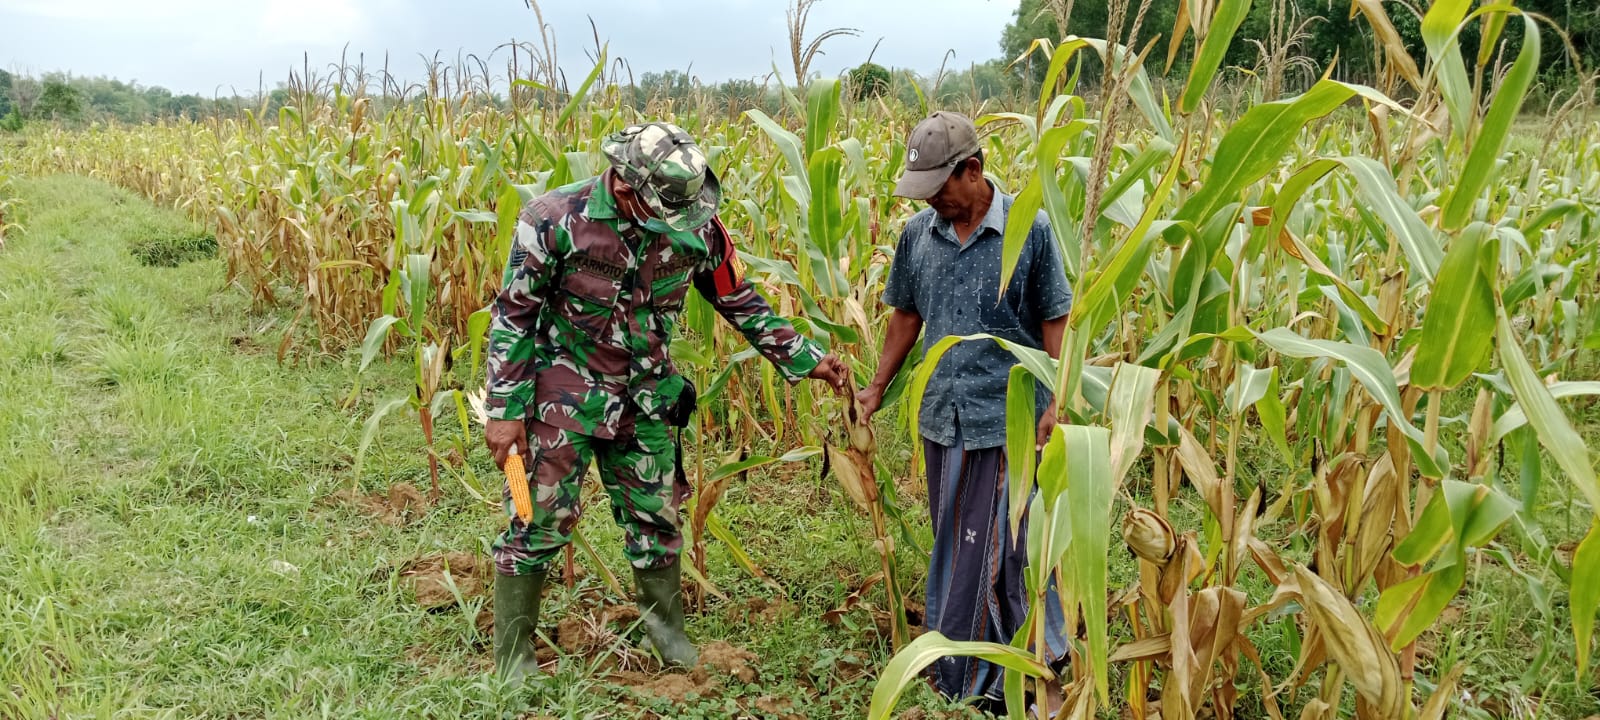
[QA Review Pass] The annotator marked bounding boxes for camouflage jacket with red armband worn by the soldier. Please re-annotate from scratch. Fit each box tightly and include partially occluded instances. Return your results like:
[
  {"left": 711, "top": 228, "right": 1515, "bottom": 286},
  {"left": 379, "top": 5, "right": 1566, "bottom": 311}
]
[{"left": 486, "top": 171, "right": 822, "bottom": 438}]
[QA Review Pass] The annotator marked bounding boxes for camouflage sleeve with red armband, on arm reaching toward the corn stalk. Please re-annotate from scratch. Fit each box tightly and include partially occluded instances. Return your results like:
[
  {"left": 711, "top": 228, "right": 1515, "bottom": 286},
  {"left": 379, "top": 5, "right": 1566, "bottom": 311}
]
[{"left": 694, "top": 219, "right": 824, "bottom": 382}]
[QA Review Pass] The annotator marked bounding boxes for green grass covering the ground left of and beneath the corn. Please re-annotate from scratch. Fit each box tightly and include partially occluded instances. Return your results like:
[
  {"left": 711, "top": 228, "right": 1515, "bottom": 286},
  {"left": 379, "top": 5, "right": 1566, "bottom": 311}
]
[{"left": 0, "top": 178, "right": 1600, "bottom": 718}]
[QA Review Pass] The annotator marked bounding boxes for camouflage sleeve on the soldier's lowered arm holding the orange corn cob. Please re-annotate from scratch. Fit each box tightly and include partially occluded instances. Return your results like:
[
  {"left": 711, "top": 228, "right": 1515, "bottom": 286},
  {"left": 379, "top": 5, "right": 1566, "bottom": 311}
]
[{"left": 485, "top": 211, "right": 554, "bottom": 419}]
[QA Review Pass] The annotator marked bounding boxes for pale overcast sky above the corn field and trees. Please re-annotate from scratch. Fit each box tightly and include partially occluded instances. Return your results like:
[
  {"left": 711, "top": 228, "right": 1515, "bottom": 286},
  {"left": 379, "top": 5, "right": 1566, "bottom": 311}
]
[{"left": 0, "top": 0, "right": 1018, "bottom": 96}]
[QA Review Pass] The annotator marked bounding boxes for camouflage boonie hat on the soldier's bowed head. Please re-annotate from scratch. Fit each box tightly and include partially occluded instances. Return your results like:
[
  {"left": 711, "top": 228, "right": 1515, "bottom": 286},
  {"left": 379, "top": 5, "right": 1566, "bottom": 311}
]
[{"left": 600, "top": 123, "right": 722, "bottom": 230}]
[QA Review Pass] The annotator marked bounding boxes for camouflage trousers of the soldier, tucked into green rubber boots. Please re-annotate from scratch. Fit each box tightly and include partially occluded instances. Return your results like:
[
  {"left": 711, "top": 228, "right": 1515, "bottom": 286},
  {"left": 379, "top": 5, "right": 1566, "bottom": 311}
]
[{"left": 493, "top": 418, "right": 690, "bottom": 574}]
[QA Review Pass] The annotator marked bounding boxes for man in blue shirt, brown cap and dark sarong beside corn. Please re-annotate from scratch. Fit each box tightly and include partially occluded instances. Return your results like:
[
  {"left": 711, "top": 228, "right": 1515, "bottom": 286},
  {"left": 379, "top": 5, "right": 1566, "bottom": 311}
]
[{"left": 858, "top": 112, "right": 1072, "bottom": 701}]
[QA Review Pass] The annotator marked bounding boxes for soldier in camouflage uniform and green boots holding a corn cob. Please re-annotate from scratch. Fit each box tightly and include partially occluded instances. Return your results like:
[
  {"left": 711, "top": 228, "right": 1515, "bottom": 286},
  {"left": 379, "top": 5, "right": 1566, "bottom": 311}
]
[{"left": 485, "top": 123, "right": 845, "bottom": 677}]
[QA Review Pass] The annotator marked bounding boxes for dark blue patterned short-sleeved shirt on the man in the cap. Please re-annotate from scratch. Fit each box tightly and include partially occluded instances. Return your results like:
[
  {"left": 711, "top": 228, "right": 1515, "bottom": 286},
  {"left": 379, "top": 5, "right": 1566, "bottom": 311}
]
[{"left": 883, "top": 184, "right": 1072, "bottom": 450}]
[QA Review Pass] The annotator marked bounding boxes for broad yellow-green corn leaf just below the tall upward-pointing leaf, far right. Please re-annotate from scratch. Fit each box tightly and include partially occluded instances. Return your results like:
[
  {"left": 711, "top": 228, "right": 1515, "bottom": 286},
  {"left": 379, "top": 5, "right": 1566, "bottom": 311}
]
[{"left": 1411, "top": 222, "right": 1499, "bottom": 390}]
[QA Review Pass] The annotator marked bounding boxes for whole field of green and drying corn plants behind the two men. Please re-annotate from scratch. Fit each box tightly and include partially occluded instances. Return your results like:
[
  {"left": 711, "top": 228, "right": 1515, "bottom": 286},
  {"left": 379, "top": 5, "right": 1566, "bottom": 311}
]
[{"left": 0, "top": 0, "right": 1600, "bottom": 720}]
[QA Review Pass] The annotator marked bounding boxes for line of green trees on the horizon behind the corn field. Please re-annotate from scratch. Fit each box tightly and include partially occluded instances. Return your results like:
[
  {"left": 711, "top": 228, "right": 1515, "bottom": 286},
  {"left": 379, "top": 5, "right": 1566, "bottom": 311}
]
[{"left": 0, "top": 0, "right": 1600, "bottom": 130}]
